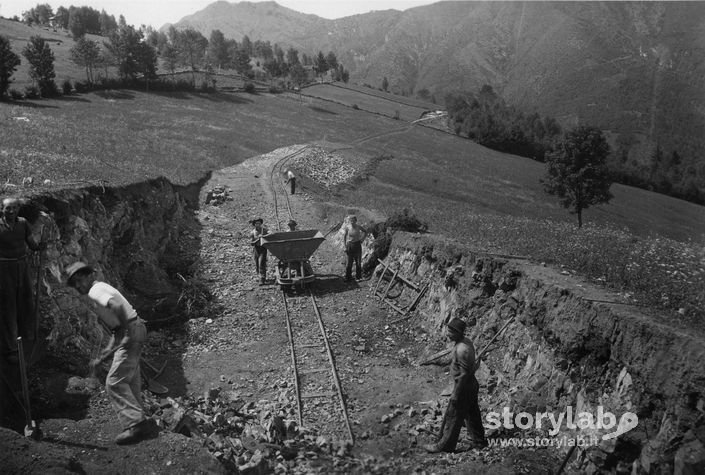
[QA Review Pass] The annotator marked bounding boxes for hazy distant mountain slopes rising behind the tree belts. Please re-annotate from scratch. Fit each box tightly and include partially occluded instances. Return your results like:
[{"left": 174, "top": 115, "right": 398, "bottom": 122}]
[{"left": 175, "top": 1, "right": 705, "bottom": 176}]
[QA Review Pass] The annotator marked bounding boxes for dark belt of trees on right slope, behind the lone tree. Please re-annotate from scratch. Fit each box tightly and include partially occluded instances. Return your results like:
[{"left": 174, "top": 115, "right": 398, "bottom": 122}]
[{"left": 445, "top": 85, "right": 705, "bottom": 204}]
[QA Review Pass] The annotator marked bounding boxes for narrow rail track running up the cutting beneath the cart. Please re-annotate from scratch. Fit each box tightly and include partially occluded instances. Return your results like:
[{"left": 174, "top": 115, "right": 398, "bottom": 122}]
[{"left": 270, "top": 147, "right": 355, "bottom": 444}]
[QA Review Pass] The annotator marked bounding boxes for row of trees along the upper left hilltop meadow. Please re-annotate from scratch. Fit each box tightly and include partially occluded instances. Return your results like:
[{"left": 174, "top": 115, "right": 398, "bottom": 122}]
[{"left": 0, "top": 4, "right": 349, "bottom": 97}]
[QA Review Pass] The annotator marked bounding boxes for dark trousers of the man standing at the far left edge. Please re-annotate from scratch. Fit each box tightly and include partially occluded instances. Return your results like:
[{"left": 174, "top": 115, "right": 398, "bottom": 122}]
[{"left": 0, "top": 258, "right": 36, "bottom": 357}]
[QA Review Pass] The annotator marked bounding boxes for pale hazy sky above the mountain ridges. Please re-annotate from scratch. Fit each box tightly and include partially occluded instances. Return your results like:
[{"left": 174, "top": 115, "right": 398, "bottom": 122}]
[{"left": 0, "top": 0, "right": 438, "bottom": 28}]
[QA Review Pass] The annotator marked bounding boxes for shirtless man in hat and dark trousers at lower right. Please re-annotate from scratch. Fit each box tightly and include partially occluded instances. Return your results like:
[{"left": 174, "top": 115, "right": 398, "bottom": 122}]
[{"left": 424, "top": 318, "right": 487, "bottom": 453}]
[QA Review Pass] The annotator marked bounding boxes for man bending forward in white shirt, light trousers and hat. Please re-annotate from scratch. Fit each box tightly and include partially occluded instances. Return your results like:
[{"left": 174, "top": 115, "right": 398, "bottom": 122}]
[{"left": 66, "top": 262, "right": 157, "bottom": 445}]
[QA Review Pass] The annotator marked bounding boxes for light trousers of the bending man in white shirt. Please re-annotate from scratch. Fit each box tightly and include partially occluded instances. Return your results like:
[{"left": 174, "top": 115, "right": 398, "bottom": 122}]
[{"left": 105, "top": 318, "right": 147, "bottom": 429}]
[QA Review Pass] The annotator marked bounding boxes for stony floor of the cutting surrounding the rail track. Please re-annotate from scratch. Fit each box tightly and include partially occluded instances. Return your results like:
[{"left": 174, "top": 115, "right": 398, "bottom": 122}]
[{"left": 0, "top": 146, "right": 560, "bottom": 473}]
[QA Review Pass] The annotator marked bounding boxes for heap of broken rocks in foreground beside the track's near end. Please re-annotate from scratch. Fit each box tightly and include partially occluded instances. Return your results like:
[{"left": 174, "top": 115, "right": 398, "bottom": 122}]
[{"left": 145, "top": 385, "right": 368, "bottom": 473}]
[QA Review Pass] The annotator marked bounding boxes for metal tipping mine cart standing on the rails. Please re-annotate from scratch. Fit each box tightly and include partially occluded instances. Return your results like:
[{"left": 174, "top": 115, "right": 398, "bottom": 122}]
[{"left": 260, "top": 229, "right": 325, "bottom": 287}]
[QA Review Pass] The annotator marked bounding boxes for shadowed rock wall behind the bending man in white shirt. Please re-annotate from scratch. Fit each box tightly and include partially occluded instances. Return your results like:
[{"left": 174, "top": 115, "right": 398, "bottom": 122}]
[{"left": 23, "top": 179, "right": 192, "bottom": 351}]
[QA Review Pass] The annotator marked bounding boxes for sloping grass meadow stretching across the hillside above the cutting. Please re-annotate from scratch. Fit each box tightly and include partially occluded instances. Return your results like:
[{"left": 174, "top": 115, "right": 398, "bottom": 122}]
[{"left": 0, "top": 78, "right": 705, "bottom": 327}]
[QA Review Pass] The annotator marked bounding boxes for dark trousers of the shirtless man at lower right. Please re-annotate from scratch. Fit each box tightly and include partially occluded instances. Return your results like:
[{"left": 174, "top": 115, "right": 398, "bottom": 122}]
[{"left": 438, "top": 376, "right": 485, "bottom": 452}]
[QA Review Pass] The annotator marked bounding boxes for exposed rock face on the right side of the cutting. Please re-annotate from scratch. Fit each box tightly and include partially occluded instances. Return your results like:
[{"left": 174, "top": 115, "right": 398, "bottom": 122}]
[{"left": 380, "top": 233, "right": 705, "bottom": 473}]
